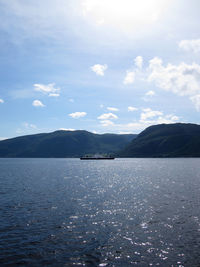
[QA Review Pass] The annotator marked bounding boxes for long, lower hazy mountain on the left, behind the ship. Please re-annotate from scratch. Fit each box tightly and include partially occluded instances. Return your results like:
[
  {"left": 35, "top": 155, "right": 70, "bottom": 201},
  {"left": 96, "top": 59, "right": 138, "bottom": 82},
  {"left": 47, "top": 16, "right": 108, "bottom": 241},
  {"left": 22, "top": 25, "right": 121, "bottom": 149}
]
[{"left": 0, "top": 131, "right": 136, "bottom": 158}]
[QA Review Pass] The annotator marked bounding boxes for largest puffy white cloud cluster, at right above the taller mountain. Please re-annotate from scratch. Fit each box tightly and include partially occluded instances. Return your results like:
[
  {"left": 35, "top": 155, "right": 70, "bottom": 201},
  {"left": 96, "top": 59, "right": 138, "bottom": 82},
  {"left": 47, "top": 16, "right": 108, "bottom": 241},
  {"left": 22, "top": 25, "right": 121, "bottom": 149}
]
[{"left": 121, "top": 56, "right": 200, "bottom": 111}]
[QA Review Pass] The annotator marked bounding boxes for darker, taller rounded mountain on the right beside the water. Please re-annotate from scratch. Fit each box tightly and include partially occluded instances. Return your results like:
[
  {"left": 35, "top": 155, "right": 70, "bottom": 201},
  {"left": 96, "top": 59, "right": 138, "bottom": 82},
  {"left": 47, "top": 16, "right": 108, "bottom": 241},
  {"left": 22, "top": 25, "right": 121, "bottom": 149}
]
[{"left": 118, "top": 123, "right": 200, "bottom": 157}]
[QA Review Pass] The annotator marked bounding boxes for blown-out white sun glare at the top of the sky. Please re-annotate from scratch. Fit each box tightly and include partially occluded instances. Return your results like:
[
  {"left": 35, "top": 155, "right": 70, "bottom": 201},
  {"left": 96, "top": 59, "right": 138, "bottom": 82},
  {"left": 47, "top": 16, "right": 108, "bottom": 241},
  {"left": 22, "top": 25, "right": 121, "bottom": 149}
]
[{"left": 83, "top": 0, "right": 169, "bottom": 30}]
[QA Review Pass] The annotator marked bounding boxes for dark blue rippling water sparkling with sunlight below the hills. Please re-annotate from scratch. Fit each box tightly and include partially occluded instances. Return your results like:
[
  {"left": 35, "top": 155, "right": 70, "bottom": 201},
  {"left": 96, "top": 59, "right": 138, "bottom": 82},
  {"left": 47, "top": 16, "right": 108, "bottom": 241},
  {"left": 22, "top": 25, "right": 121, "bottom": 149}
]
[{"left": 0, "top": 159, "right": 200, "bottom": 267}]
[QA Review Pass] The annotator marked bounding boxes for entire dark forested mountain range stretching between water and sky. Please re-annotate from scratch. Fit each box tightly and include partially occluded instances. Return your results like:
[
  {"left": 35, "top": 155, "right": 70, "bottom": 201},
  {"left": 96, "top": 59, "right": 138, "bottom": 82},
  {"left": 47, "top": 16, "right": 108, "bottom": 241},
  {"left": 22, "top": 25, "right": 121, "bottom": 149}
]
[{"left": 0, "top": 123, "right": 200, "bottom": 158}]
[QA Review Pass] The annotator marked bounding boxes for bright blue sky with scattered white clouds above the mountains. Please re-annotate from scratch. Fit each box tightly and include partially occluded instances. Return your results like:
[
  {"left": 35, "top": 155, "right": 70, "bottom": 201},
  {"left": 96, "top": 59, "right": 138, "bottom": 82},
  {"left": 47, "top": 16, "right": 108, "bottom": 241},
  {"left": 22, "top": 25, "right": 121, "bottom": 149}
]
[{"left": 0, "top": 0, "right": 200, "bottom": 140}]
